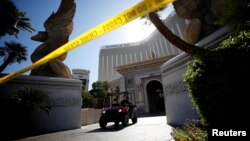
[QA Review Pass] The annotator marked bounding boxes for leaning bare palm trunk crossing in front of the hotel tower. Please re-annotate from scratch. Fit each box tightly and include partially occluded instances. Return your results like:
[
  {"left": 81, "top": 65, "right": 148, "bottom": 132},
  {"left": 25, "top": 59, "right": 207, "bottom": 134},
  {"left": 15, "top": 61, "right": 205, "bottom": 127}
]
[{"left": 149, "top": 12, "right": 208, "bottom": 57}]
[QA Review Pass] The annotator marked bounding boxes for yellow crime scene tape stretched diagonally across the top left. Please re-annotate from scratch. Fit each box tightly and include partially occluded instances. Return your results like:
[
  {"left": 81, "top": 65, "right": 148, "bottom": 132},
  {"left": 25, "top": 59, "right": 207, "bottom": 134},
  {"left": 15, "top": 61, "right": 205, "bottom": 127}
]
[{"left": 0, "top": 0, "right": 174, "bottom": 84}]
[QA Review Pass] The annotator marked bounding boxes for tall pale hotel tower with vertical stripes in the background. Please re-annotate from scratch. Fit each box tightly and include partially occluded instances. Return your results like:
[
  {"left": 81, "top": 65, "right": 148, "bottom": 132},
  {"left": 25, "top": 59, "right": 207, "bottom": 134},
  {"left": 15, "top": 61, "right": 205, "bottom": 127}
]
[{"left": 98, "top": 12, "right": 187, "bottom": 82}]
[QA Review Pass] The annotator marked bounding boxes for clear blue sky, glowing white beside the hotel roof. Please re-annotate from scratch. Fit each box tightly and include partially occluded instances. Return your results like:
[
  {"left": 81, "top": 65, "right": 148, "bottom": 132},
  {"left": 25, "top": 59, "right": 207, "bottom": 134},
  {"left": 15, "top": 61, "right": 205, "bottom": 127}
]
[{"left": 0, "top": 0, "right": 173, "bottom": 87}]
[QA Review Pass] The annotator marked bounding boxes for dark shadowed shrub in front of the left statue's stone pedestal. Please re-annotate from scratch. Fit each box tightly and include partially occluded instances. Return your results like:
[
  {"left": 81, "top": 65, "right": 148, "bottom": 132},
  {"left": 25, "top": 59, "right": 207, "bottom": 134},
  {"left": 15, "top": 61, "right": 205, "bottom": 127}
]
[{"left": 1, "top": 86, "right": 51, "bottom": 140}]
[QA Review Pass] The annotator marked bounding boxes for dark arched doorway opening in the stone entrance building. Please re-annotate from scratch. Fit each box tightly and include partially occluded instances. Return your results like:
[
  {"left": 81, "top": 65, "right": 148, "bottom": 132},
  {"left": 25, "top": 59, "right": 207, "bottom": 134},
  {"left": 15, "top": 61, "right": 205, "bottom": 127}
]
[{"left": 146, "top": 80, "right": 165, "bottom": 113}]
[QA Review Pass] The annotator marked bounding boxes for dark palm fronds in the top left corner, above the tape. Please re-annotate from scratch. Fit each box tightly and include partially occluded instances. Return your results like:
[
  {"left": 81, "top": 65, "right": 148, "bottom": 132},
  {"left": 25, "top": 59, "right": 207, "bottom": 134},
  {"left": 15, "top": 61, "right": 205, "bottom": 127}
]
[{"left": 0, "top": 0, "right": 35, "bottom": 37}]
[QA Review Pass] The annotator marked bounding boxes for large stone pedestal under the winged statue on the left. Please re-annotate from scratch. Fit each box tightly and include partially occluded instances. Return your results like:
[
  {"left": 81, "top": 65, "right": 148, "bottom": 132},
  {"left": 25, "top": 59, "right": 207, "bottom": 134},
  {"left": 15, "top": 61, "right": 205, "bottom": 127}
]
[{"left": 0, "top": 76, "right": 82, "bottom": 133}]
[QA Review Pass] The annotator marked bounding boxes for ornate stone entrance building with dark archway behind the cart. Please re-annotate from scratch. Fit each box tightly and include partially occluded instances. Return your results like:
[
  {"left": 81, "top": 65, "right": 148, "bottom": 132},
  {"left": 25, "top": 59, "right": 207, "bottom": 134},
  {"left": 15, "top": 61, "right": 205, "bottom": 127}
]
[{"left": 116, "top": 55, "right": 176, "bottom": 114}]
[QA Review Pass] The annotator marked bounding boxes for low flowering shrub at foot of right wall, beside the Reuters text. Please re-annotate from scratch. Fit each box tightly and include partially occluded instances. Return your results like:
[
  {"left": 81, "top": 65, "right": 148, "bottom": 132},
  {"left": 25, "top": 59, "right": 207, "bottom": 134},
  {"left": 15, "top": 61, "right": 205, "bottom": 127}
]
[{"left": 171, "top": 120, "right": 208, "bottom": 141}]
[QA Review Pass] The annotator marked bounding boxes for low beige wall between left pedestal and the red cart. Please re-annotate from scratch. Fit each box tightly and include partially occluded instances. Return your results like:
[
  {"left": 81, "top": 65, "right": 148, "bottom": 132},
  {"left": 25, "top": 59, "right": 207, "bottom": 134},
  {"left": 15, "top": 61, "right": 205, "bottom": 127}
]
[{"left": 82, "top": 108, "right": 102, "bottom": 126}]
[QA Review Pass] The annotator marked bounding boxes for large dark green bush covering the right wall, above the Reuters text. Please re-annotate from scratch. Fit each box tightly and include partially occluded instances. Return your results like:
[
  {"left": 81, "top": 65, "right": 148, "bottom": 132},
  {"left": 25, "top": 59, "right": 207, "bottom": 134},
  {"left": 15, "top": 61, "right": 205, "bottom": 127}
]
[{"left": 184, "top": 31, "right": 250, "bottom": 128}]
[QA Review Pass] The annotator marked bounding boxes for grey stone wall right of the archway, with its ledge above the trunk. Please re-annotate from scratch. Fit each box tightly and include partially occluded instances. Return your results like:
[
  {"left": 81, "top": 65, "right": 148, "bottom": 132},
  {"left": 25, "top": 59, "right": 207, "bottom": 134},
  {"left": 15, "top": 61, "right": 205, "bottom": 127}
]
[{"left": 161, "top": 27, "right": 230, "bottom": 125}]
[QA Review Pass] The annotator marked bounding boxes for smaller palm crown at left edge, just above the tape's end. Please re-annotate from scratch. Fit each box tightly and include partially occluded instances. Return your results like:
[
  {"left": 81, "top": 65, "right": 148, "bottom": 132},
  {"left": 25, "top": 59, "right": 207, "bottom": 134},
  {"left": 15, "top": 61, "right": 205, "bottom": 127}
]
[{"left": 0, "top": 41, "right": 27, "bottom": 72}]
